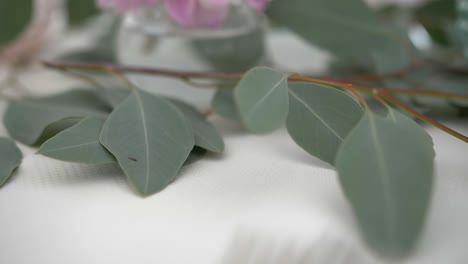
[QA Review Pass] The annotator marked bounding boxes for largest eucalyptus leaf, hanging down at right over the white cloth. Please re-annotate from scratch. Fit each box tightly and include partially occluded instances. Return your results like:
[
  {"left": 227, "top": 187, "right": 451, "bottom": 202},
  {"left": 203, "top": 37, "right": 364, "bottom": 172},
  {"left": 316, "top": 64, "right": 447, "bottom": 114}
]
[{"left": 335, "top": 111, "right": 435, "bottom": 256}]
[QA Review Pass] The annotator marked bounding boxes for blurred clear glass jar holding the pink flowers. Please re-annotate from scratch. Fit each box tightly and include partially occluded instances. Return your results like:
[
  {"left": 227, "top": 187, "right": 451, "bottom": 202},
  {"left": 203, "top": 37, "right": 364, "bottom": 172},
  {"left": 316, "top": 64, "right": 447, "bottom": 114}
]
[{"left": 117, "top": 1, "right": 267, "bottom": 108}]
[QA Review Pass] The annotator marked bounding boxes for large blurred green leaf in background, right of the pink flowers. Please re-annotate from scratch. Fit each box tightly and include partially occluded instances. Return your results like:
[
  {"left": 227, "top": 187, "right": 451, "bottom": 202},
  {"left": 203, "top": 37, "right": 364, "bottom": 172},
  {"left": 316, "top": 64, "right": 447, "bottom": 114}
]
[{"left": 267, "top": 0, "right": 407, "bottom": 69}]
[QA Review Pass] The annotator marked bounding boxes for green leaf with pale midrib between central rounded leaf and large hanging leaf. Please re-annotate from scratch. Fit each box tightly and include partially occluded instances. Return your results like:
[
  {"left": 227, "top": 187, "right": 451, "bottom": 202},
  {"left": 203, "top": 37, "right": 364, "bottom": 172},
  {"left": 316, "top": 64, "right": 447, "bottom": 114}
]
[{"left": 286, "top": 83, "right": 364, "bottom": 164}]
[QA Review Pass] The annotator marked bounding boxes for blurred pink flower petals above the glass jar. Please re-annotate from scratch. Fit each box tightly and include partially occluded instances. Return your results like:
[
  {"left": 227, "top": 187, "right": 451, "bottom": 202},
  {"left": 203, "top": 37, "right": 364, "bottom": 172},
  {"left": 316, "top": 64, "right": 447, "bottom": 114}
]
[{"left": 97, "top": 0, "right": 270, "bottom": 27}]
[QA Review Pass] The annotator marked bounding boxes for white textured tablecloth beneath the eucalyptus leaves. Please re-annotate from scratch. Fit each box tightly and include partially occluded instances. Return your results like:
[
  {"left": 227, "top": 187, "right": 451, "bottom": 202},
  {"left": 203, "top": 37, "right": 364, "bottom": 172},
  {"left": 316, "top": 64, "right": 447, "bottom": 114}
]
[{"left": 0, "top": 24, "right": 468, "bottom": 264}]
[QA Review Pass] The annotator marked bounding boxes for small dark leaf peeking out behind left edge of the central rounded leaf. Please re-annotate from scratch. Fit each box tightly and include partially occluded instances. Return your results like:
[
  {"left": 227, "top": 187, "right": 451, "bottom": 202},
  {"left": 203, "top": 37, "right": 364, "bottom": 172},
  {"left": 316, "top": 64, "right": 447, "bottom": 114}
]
[{"left": 211, "top": 89, "right": 241, "bottom": 121}]
